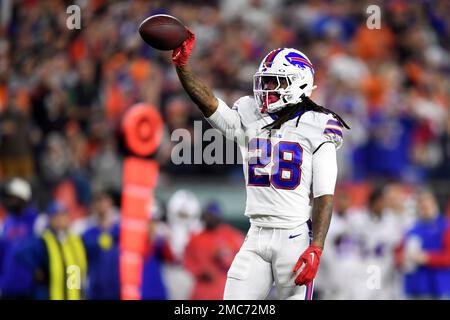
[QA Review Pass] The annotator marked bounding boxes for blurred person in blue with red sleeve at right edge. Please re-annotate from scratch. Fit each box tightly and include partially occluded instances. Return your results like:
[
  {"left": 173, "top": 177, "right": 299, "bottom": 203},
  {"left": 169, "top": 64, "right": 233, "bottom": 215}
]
[{"left": 404, "top": 190, "right": 450, "bottom": 299}]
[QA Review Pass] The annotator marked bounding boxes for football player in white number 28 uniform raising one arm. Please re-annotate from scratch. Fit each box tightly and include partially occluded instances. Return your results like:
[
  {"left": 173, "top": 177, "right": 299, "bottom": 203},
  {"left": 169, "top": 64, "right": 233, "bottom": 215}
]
[{"left": 172, "top": 31, "right": 348, "bottom": 300}]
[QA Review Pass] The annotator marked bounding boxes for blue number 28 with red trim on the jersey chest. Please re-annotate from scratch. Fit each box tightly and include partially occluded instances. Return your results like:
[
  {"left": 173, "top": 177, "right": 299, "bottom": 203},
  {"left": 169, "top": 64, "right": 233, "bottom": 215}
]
[{"left": 248, "top": 138, "right": 303, "bottom": 190}]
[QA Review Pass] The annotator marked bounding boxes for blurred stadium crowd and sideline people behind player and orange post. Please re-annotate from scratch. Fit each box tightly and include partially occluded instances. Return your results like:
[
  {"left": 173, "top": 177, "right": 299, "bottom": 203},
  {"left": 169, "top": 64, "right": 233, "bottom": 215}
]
[{"left": 0, "top": 0, "right": 450, "bottom": 299}]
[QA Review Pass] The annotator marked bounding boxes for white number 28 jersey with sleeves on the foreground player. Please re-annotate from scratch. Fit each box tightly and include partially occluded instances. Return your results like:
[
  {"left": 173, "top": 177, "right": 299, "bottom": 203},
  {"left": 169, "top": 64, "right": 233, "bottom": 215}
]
[{"left": 207, "top": 96, "right": 343, "bottom": 228}]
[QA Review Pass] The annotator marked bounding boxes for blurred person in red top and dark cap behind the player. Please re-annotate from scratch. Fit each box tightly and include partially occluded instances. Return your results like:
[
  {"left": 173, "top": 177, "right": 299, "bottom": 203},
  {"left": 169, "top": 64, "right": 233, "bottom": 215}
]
[{"left": 184, "top": 202, "right": 244, "bottom": 300}]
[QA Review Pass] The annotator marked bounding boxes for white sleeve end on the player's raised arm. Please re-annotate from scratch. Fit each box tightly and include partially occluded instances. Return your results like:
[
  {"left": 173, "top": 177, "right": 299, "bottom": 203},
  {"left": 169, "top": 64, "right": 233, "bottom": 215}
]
[{"left": 206, "top": 98, "right": 242, "bottom": 139}]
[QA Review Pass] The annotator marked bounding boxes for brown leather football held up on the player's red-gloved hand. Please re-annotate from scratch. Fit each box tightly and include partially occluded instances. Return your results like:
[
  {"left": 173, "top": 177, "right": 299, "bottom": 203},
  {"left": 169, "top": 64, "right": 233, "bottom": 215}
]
[{"left": 139, "top": 14, "right": 188, "bottom": 51}]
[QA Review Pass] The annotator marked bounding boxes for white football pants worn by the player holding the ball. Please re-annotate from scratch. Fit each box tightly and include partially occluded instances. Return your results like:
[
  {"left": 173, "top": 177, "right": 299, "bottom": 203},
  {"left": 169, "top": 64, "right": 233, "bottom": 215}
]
[{"left": 224, "top": 223, "right": 314, "bottom": 300}]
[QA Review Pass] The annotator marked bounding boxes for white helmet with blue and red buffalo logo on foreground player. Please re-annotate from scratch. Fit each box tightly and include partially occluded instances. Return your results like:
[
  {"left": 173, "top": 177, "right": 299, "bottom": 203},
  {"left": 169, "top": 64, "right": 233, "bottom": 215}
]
[{"left": 253, "top": 48, "right": 316, "bottom": 113}]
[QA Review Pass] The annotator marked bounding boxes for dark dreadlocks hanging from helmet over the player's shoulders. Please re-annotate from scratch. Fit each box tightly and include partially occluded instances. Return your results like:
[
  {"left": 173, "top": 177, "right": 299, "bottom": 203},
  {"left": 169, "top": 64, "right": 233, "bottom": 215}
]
[{"left": 263, "top": 95, "right": 350, "bottom": 132}]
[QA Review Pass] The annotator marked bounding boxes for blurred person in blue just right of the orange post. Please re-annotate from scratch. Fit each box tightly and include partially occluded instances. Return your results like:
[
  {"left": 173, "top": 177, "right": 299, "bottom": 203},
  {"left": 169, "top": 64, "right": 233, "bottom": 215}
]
[{"left": 141, "top": 205, "right": 174, "bottom": 300}]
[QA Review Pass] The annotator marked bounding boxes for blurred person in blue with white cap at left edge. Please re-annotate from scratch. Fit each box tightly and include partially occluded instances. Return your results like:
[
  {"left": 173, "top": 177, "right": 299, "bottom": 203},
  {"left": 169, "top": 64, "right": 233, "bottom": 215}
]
[{"left": 0, "top": 178, "right": 38, "bottom": 299}]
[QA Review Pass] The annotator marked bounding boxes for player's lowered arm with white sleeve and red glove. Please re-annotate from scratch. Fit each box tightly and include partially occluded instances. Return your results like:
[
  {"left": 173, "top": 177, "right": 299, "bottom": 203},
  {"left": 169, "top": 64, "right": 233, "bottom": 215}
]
[{"left": 294, "top": 141, "right": 337, "bottom": 285}]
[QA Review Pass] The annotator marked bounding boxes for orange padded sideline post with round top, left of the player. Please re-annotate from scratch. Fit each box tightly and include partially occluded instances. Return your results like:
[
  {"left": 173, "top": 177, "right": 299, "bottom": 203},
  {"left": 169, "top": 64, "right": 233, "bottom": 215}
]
[{"left": 120, "top": 103, "right": 163, "bottom": 300}]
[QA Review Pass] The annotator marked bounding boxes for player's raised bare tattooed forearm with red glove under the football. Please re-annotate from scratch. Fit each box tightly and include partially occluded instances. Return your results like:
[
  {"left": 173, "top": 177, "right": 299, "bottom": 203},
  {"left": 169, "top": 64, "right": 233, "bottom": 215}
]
[{"left": 172, "top": 29, "right": 219, "bottom": 118}]
